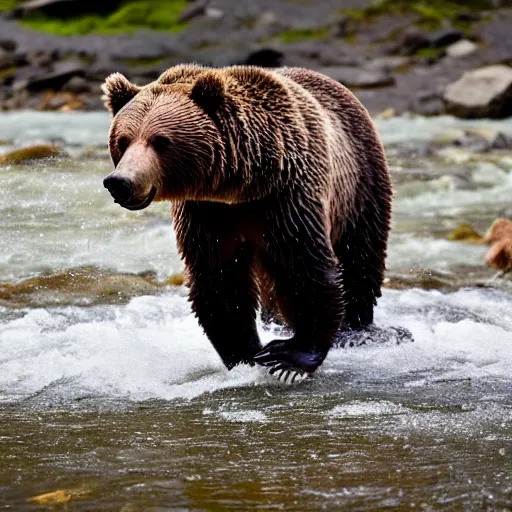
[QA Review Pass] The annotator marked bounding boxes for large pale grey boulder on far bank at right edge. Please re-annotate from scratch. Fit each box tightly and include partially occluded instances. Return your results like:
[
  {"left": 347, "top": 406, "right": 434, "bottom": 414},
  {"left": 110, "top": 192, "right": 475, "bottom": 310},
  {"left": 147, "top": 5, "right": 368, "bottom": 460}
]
[{"left": 444, "top": 65, "right": 512, "bottom": 119}]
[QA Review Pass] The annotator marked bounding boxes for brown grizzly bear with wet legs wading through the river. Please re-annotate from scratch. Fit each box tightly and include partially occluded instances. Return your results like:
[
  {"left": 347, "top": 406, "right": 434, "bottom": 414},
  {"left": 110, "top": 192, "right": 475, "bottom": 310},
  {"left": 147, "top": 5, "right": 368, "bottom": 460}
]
[{"left": 103, "top": 65, "right": 392, "bottom": 381}]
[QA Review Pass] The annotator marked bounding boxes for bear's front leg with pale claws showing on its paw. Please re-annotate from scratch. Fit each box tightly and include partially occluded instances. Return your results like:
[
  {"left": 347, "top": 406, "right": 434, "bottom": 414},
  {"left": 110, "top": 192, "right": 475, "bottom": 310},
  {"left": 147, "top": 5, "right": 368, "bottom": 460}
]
[{"left": 254, "top": 196, "right": 345, "bottom": 382}]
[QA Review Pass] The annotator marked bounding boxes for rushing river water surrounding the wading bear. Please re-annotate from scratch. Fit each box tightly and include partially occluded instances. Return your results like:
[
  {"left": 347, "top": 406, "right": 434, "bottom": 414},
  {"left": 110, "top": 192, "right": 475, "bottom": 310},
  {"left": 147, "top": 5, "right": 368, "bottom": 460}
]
[{"left": 0, "top": 112, "right": 512, "bottom": 512}]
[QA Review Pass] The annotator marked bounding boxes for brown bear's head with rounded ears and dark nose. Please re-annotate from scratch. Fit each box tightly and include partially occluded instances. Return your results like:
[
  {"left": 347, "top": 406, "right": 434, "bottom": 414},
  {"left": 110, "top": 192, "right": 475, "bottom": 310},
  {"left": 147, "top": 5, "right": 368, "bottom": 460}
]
[{"left": 103, "top": 72, "right": 225, "bottom": 210}]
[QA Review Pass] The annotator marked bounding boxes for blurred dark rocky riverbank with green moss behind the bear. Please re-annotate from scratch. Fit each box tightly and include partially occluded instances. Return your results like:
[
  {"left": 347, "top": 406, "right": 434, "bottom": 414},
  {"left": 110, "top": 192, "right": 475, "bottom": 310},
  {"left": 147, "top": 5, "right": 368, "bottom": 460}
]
[{"left": 0, "top": 0, "right": 512, "bottom": 117}]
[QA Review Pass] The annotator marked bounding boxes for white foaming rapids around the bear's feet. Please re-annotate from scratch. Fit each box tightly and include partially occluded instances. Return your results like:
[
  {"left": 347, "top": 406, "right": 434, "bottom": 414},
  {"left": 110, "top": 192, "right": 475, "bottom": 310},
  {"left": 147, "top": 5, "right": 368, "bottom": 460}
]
[{"left": 0, "top": 290, "right": 512, "bottom": 404}]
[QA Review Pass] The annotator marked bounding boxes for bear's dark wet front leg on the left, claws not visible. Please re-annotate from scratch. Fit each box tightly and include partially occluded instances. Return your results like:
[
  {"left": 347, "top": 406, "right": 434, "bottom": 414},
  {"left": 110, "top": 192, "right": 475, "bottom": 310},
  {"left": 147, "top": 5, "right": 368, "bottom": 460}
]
[{"left": 175, "top": 203, "right": 261, "bottom": 369}]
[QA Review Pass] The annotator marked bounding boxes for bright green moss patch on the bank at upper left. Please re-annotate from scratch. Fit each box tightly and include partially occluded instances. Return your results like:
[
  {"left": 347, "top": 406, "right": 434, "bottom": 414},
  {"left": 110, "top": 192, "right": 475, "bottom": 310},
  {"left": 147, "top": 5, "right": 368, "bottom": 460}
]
[{"left": 16, "top": 0, "right": 187, "bottom": 36}]
